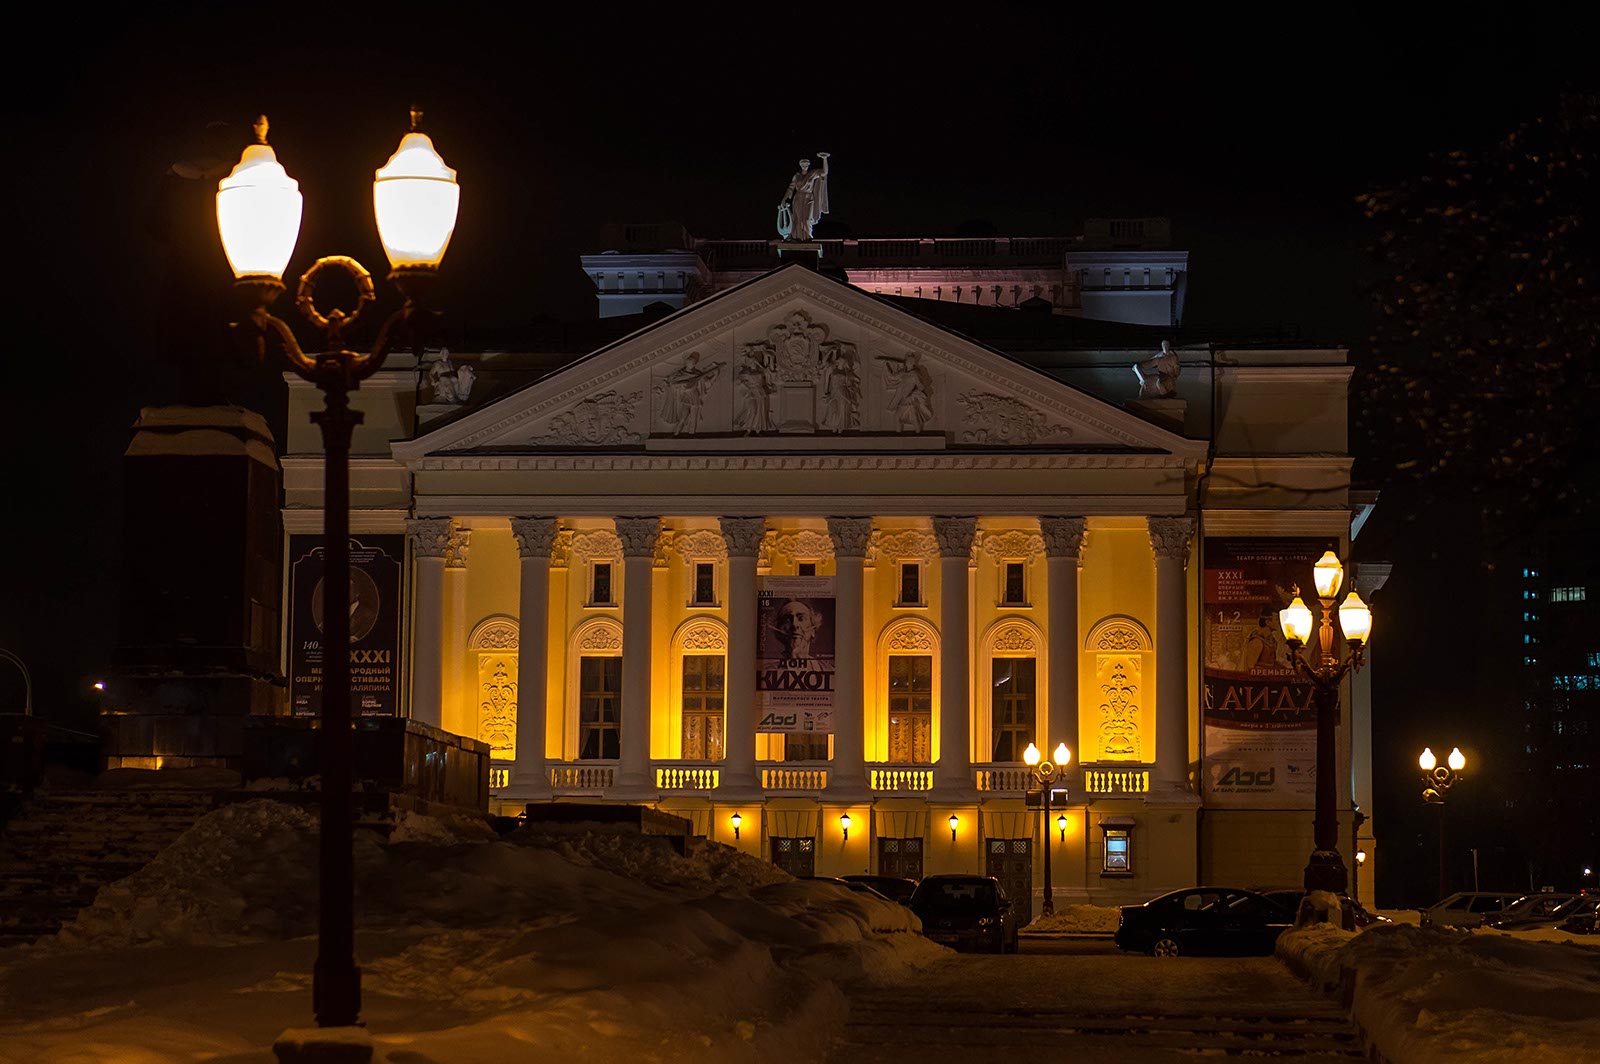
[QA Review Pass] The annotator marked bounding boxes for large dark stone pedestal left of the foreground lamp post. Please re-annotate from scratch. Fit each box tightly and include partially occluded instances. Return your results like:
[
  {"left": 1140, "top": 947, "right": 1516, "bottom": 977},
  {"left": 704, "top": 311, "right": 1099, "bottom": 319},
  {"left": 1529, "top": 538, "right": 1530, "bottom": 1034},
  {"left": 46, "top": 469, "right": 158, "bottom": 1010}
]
[{"left": 101, "top": 406, "right": 285, "bottom": 768}]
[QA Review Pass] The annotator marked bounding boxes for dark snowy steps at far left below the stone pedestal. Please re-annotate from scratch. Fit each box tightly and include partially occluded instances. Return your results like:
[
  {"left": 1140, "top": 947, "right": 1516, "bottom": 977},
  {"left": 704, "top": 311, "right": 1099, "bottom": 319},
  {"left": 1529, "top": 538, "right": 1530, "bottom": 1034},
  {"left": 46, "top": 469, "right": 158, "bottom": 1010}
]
[{"left": 0, "top": 789, "right": 211, "bottom": 947}]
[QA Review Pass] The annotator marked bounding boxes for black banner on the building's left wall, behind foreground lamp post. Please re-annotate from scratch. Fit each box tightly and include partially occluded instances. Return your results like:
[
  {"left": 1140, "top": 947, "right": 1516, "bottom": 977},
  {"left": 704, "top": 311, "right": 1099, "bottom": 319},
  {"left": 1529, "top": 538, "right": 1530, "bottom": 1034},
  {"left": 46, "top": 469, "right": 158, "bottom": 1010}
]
[{"left": 290, "top": 536, "right": 405, "bottom": 717}]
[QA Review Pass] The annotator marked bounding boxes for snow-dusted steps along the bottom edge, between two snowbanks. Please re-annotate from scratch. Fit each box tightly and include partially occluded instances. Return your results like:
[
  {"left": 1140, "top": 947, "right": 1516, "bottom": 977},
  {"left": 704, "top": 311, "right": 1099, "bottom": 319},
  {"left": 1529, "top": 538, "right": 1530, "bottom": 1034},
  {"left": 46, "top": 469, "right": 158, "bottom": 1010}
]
[{"left": 830, "top": 995, "right": 1366, "bottom": 1064}]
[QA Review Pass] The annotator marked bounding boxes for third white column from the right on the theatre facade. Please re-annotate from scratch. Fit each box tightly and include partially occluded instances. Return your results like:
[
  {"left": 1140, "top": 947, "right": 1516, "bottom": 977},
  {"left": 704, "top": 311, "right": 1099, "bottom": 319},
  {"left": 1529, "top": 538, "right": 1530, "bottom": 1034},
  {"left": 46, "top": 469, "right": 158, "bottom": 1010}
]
[{"left": 933, "top": 517, "right": 978, "bottom": 794}]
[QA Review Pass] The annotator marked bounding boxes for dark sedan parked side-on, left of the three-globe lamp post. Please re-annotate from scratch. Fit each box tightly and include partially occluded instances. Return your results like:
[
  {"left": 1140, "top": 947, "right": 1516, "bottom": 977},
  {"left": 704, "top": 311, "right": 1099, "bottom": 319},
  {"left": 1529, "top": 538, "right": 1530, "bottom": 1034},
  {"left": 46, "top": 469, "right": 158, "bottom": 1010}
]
[{"left": 1115, "top": 886, "right": 1293, "bottom": 957}]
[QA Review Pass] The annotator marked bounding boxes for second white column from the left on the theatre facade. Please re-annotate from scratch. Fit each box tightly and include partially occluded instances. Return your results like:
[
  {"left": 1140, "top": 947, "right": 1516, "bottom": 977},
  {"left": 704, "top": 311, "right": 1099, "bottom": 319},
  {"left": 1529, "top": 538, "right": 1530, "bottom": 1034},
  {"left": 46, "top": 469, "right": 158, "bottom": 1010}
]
[{"left": 504, "top": 517, "right": 555, "bottom": 798}]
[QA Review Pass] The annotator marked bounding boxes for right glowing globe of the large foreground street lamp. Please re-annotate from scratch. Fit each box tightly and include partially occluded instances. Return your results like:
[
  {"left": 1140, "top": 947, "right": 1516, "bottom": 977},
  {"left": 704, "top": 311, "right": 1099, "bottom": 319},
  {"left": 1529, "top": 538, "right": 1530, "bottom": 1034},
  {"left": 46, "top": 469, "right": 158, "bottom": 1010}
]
[{"left": 373, "top": 133, "right": 461, "bottom": 270}]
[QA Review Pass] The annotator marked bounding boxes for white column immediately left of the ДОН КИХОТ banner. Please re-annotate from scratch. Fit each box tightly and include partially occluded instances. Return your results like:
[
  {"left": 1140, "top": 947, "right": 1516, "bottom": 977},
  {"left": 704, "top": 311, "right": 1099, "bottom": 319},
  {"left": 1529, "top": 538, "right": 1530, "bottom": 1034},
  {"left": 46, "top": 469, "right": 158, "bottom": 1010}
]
[{"left": 717, "top": 517, "right": 766, "bottom": 795}]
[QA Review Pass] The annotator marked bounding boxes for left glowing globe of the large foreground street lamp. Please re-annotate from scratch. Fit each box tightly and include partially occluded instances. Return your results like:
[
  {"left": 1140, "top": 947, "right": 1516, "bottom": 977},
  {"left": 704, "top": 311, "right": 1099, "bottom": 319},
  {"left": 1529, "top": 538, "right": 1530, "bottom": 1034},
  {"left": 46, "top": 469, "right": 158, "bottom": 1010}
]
[{"left": 216, "top": 118, "right": 301, "bottom": 280}]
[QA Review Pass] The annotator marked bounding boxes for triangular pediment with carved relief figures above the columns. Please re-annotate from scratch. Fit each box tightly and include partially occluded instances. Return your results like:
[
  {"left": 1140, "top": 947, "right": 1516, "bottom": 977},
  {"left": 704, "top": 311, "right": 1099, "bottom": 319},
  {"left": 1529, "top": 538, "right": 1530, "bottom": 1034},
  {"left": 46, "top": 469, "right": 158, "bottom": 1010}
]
[{"left": 394, "top": 266, "right": 1205, "bottom": 462}]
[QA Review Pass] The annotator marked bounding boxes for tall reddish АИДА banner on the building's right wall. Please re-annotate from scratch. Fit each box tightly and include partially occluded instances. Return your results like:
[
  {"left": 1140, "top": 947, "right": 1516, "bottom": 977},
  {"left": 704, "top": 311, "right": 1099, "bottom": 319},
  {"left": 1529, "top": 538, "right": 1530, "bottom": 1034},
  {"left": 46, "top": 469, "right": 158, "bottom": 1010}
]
[{"left": 1200, "top": 538, "right": 1338, "bottom": 810}]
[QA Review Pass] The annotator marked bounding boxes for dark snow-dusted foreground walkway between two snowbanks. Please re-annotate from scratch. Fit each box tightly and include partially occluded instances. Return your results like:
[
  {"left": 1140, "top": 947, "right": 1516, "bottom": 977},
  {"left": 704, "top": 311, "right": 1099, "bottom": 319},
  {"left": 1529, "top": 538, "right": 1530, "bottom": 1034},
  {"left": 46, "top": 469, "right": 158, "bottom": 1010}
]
[{"left": 829, "top": 939, "right": 1363, "bottom": 1064}]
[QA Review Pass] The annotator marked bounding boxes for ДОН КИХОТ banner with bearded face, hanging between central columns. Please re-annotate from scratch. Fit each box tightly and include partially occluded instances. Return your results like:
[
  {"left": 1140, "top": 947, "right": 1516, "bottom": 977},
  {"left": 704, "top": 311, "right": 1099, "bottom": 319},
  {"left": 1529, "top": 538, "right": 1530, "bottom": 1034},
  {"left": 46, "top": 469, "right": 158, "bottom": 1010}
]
[{"left": 755, "top": 576, "right": 835, "bottom": 733}]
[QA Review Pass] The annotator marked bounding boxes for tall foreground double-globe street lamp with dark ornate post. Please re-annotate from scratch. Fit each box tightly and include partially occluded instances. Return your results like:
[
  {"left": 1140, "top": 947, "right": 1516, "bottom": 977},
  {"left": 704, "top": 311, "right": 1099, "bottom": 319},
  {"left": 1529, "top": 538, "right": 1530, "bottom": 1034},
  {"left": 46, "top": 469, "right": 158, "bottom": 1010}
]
[{"left": 216, "top": 109, "right": 461, "bottom": 1027}]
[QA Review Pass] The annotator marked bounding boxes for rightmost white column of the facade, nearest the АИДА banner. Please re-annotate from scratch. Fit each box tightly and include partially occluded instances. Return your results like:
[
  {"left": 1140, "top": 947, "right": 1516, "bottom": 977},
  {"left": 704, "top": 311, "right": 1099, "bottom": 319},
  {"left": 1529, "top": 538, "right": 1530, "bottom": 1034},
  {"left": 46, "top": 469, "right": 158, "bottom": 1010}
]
[{"left": 1149, "top": 517, "right": 1195, "bottom": 790}]
